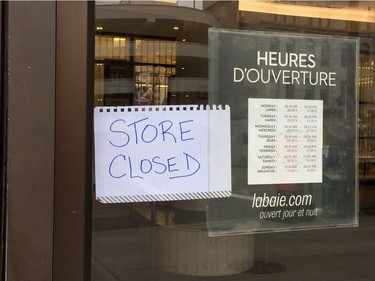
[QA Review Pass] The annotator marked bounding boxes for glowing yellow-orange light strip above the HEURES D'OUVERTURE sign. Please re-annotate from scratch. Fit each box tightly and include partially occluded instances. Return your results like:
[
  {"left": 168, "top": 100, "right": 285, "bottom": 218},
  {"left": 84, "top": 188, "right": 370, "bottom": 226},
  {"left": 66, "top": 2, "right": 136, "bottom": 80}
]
[{"left": 239, "top": 0, "right": 375, "bottom": 22}]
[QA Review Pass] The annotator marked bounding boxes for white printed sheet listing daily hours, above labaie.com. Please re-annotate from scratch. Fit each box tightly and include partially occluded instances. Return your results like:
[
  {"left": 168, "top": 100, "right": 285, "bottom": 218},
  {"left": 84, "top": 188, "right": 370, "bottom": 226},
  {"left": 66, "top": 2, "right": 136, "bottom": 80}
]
[{"left": 248, "top": 98, "right": 323, "bottom": 184}]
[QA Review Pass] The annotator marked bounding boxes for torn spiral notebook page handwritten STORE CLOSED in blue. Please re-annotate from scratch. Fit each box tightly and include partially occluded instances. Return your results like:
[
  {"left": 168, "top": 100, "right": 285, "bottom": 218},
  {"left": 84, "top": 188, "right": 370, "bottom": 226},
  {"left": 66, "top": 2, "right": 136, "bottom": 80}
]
[{"left": 94, "top": 105, "right": 231, "bottom": 203}]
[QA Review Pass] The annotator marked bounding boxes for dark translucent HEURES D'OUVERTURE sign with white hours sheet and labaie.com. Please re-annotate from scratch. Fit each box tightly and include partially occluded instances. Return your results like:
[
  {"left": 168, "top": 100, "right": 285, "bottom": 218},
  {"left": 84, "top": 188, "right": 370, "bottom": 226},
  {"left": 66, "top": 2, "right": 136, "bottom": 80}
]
[{"left": 207, "top": 28, "right": 359, "bottom": 236}]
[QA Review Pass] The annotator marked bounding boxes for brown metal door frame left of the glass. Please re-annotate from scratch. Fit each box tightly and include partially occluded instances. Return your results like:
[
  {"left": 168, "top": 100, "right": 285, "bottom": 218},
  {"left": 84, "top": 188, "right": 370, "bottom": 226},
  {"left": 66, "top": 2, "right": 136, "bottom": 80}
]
[{"left": 4, "top": 1, "right": 95, "bottom": 281}]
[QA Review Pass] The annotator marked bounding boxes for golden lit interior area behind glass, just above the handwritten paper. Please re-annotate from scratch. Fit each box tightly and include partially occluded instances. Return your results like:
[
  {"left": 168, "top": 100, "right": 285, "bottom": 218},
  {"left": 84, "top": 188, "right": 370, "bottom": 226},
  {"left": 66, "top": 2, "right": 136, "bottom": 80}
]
[{"left": 95, "top": 35, "right": 176, "bottom": 105}]
